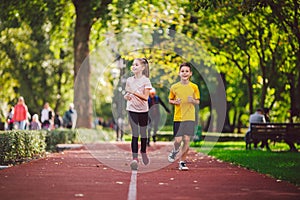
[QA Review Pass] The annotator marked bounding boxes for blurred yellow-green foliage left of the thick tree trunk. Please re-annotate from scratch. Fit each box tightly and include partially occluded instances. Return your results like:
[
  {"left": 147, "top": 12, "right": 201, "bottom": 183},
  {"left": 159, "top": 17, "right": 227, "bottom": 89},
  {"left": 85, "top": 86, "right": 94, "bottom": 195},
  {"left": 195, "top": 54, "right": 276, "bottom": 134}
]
[{"left": 0, "top": 0, "right": 74, "bottom": 114}]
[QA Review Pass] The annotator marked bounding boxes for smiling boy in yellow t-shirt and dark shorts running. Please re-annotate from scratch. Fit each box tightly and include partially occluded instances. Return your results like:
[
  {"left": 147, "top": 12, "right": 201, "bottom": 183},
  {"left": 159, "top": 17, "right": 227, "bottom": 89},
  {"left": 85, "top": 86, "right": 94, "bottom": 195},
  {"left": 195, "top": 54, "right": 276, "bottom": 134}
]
[{"left": 168, "top": 63, "right": 200, "bottom": 170}]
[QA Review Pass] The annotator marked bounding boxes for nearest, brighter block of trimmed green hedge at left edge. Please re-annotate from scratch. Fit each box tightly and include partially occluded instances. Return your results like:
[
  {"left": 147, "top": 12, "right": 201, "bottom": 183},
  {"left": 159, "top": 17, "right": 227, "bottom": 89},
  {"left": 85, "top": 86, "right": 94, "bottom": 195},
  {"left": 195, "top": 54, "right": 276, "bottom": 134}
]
[{"left": 0, "top": 131, "right": 46, "bottom": 164}]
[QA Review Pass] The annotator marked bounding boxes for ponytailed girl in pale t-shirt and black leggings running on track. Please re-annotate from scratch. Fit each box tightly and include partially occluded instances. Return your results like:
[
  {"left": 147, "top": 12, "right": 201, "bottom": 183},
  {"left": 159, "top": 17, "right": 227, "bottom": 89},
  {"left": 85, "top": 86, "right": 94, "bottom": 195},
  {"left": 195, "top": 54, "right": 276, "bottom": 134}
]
[{"left": 124, "top": 58, "right": 152, "bottom": 170}]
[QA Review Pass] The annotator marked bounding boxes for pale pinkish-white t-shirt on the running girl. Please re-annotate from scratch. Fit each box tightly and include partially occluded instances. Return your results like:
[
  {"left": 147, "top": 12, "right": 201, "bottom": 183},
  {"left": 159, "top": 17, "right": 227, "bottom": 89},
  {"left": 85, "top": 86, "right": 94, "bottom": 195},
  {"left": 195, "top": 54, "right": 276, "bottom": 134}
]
[{"left": 126, "top": 75, "right": 152, "bottom": 112}]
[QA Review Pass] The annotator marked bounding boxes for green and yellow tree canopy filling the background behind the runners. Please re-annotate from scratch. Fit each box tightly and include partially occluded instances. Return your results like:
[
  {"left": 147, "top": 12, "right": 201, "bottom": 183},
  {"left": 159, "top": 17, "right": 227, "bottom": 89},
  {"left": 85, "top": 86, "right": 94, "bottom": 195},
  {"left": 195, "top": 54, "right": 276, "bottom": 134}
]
[{"left": 0, "top": 0, "right": 300, "bottom": 131}]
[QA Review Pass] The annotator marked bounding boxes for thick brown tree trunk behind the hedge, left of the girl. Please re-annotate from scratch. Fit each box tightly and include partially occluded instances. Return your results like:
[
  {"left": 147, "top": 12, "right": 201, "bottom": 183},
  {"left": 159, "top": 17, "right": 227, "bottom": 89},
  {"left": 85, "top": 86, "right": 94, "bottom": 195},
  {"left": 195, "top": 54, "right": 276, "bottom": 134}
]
[{"left": 73, "top": 0, "right": 92, "bottom": 128}]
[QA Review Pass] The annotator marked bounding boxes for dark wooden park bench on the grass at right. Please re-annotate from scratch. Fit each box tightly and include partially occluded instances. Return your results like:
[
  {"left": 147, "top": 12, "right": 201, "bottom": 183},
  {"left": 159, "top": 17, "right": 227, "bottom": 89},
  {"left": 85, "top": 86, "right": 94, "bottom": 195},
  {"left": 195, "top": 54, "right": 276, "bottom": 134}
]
[{"left": 250, "top": 123, "right": 300, "bottom": 151}]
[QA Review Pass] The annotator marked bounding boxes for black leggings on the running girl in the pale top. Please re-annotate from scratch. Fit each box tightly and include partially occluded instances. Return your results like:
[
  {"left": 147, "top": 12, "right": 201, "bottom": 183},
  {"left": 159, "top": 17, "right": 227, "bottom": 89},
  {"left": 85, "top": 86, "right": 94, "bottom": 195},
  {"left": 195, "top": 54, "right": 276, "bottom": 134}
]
[{"left": 129, "top": 111, "right": 148, "bottom": 158}]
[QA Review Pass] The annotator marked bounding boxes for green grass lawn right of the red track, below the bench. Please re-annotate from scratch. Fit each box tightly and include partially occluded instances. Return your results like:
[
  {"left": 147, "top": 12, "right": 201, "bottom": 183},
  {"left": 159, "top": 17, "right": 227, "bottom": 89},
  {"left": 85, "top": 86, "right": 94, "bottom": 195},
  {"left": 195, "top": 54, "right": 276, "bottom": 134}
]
[{"left": 191, "top": 141, "right": 300, "bottom": 185}]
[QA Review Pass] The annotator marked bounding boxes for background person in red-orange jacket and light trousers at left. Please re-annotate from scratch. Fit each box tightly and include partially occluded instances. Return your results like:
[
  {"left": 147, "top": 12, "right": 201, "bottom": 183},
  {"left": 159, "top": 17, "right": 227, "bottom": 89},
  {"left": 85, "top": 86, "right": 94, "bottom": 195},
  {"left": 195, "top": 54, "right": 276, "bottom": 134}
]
[{"left": 13, "top": 96, "right": 28, "bottom": 130}]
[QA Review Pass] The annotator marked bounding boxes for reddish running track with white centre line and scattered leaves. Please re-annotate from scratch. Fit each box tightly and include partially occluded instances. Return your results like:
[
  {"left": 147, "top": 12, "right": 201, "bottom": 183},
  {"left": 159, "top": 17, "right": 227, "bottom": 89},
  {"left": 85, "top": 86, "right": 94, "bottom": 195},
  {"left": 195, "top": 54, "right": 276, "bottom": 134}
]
[{"left": 0, "top": 143, "right": 300, "bottom": 200}]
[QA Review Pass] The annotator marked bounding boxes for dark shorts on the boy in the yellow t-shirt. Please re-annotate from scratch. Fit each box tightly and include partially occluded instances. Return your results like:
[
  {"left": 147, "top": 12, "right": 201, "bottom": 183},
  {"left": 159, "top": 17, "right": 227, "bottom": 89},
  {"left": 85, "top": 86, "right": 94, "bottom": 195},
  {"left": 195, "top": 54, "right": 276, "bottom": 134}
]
[{"left": 173, "top": 121, "right": 196, "bottom": 137}]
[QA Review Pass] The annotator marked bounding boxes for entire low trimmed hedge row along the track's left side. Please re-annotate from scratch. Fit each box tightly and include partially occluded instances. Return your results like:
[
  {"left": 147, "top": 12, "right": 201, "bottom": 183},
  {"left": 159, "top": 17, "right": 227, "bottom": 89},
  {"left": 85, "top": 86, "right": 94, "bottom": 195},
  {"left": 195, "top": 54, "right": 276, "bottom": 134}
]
[{"left": 0, "top": 129, "right": 78, "bottom": 165}]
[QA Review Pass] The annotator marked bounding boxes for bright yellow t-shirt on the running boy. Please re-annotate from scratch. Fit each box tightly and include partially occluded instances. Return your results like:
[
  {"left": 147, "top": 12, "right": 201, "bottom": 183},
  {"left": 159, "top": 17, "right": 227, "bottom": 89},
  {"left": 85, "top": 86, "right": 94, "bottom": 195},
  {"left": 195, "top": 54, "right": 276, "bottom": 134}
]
[{"left": 169, "top": 82, "right": 200, "bottom": 121}]
